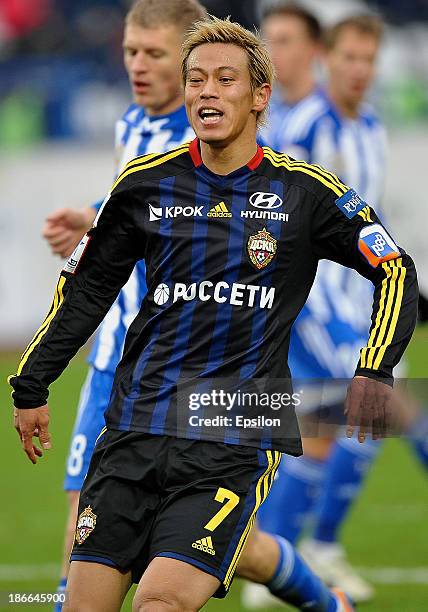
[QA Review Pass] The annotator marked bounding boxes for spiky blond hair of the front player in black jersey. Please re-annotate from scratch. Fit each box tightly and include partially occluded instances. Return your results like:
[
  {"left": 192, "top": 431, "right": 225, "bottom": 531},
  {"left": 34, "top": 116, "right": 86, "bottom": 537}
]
[{"left": 181, "top": 15, "right": 275, "bottom": 125}]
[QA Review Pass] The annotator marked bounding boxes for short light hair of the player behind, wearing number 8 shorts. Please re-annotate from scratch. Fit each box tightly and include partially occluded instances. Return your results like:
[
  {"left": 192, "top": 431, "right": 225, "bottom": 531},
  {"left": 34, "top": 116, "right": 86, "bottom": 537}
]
[{"left": 125, "top": 0, "right": 208, "bottom": 33}]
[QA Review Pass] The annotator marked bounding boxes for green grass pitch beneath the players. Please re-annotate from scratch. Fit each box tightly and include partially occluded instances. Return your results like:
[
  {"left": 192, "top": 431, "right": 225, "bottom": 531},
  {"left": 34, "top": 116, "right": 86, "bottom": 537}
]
[{"left": 0, "top": 326, "right": 428, "bottom": 612}]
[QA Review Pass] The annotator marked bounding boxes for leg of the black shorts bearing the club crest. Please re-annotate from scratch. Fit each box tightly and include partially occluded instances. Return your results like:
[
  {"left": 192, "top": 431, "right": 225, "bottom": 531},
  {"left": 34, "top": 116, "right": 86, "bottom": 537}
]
[{"left": 71, "top": 430, "right": 160, "bottom": 582}]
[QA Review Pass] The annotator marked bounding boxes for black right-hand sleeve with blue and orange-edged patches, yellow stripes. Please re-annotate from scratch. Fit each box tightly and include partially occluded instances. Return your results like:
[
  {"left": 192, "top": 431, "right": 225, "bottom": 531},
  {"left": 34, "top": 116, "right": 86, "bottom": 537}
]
[{"left": 312, "top": 189, "right": 418, "bottom": 384}]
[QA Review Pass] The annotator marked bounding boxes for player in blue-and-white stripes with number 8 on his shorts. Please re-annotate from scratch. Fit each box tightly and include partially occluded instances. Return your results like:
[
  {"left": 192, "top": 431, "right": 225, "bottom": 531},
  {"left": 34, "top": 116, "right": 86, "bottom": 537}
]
[{"left": 44, "top": 0, "right": 206, "bottom": 610}]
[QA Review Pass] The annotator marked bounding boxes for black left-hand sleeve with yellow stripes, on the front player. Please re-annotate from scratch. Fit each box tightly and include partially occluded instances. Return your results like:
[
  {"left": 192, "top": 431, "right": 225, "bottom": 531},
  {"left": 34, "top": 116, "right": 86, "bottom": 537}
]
[{"left": 9, "top": 181, "right": 145, "bottom": 408}]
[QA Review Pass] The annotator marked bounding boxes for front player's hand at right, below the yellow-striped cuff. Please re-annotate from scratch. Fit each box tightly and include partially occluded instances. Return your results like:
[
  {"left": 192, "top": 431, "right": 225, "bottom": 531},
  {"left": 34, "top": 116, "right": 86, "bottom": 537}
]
[{"left": 345, "top": 376, "right": 394, "bottom": 442}]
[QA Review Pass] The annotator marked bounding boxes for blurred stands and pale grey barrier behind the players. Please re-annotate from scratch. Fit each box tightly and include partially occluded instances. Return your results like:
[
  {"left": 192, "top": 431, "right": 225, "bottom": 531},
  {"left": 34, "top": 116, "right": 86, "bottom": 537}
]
[{"left": 0, "top": 0, "right": 428, "bottom": 348}]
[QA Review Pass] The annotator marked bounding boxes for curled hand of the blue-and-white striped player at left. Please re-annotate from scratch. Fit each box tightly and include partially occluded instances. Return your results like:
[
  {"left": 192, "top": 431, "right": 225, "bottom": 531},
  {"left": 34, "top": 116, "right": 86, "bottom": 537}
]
[{"left": 42, "top": 208, "right": 96, "bottom": 257}]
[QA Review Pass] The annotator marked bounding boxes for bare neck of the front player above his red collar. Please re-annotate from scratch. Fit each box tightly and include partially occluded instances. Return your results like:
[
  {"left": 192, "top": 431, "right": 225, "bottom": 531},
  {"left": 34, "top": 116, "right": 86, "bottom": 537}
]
[{"left": 200, "top": 132, "right": 257, "bottom": 176}]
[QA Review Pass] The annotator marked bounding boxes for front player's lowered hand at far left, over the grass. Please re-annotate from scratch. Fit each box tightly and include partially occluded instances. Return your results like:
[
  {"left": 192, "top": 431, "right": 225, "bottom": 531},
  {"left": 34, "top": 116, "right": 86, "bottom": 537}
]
[{"left": 13, "top": 404, "right": 52, "bottom": 463}]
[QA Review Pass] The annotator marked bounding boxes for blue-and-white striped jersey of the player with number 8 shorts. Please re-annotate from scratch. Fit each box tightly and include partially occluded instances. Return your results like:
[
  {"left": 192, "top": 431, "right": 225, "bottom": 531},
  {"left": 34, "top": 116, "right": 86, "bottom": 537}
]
[{"left": 88, "top": 104, "right": 194, "bottom": 373}]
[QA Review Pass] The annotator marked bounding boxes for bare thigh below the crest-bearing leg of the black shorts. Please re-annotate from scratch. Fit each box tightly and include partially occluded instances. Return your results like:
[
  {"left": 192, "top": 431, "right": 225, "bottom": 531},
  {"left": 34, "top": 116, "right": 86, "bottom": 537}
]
[{"left": 63, "top": 561, "right": 131, "bottom": 612}]
